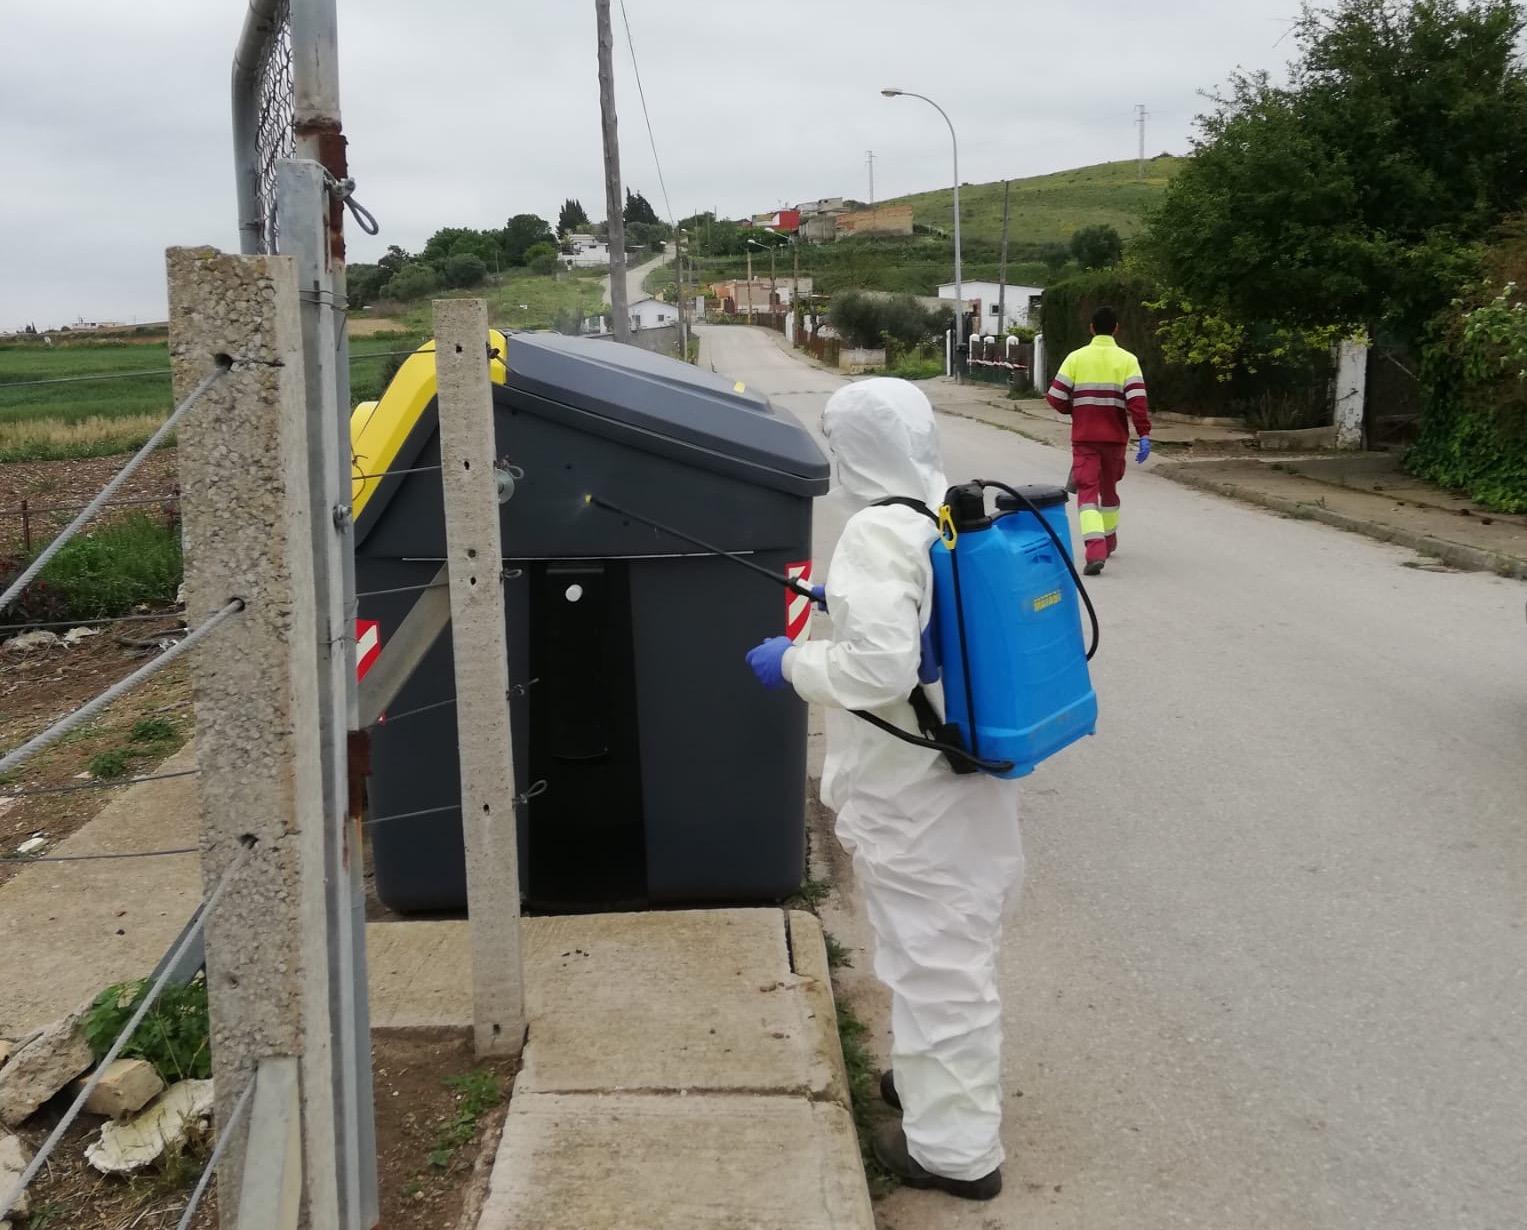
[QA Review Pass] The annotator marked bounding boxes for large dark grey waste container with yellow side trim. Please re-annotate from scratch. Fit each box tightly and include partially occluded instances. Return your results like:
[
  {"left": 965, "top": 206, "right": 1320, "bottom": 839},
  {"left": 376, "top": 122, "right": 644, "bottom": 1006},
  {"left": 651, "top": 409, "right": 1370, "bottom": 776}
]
[{"left": 356, "top": 334, "right": 828, "bottom": 913}]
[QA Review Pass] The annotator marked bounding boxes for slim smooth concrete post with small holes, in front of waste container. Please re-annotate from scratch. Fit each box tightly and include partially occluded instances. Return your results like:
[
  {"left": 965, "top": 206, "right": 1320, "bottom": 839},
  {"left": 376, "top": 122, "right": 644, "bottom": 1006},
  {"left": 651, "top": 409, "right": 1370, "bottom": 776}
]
[{"left": 434, "top": 299, "right": 525, "bottom": 1056}]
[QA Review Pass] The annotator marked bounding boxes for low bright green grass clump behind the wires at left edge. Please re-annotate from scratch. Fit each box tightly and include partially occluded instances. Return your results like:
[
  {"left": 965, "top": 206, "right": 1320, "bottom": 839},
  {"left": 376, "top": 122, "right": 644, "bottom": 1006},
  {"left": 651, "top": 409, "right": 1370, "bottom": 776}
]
[{"left": 0, "top": 513, "right": 182, "bottom": 621}]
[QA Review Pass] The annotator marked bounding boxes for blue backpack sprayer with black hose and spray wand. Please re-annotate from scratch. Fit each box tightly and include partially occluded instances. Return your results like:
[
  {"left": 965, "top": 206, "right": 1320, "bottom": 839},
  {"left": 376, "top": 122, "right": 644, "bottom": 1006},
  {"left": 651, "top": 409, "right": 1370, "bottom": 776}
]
[{"left": 585, "top": 479, "right": 1098, "bottom": 778}]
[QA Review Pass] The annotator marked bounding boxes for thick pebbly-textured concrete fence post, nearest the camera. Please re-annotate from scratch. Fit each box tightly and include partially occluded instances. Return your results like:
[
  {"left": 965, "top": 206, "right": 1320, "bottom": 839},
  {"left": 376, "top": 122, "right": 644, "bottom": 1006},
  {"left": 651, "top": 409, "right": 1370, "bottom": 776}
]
[{"left": 166, "top": 247, "right": 341, "bottom": 1230}]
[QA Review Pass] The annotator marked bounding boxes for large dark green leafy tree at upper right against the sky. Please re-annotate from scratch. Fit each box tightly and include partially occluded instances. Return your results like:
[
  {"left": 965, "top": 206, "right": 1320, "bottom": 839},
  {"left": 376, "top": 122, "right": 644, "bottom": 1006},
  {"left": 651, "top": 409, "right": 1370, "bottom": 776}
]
[{"left": 1142, "top": 0, "right": 1527, "bottom": 339}]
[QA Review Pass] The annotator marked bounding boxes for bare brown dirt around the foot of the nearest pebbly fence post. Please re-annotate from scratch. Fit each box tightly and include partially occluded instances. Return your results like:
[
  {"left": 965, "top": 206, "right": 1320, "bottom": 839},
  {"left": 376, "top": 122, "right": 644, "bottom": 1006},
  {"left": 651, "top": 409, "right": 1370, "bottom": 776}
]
[{"left": 14, "top": 1030, "right": 515, "bottom": 1230}]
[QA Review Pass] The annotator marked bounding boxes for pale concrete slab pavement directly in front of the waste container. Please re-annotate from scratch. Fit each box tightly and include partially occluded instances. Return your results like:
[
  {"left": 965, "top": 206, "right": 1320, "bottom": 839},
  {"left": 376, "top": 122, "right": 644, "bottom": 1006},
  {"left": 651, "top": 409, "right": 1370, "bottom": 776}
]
[{"left": 366, "top": 910, "right": 873, "bottom": 1230}]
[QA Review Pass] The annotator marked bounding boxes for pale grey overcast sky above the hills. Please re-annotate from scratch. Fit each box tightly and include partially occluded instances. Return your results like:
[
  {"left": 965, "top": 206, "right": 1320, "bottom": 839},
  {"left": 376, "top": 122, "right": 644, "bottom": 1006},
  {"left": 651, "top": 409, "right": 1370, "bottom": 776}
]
[{"left": 0, "top": 0, "right": 1298, "bottom": 330}]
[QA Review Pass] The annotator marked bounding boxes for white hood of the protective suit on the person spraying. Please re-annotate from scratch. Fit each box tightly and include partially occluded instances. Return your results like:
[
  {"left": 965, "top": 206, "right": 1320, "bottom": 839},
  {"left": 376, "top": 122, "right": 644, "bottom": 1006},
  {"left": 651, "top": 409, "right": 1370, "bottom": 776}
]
[{"left": 822, "top": 377, "right": 948, "bottom": 508}]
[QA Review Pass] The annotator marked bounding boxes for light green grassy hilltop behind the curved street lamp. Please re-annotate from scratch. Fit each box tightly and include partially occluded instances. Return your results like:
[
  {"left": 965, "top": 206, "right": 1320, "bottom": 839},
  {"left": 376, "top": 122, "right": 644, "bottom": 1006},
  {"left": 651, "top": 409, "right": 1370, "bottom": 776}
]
[{"left": 883, "top": 154, "right": 1186, "bottom": 243}]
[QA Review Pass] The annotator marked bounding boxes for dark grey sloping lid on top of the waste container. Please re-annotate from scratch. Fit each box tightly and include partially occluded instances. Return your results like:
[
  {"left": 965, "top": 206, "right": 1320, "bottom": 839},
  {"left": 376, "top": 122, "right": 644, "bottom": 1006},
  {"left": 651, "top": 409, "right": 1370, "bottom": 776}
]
[{"left": 504, "top": 333, "right": 831, "bottom": 494}]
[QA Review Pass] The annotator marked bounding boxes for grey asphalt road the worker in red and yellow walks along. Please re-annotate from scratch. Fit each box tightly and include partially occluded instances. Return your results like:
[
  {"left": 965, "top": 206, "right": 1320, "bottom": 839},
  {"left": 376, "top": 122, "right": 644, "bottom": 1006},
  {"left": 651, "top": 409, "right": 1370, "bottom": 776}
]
[{"left": 705, "top": 328, "right": 1527, "bottom": 1230}]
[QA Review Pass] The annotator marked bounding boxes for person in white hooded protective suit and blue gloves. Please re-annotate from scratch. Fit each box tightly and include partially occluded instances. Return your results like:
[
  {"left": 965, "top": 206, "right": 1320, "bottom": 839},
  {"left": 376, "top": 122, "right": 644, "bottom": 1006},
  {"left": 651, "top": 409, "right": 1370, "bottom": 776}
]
[{"left": 748, "top": 378, "right": 1023, "bottom": 1199}]
